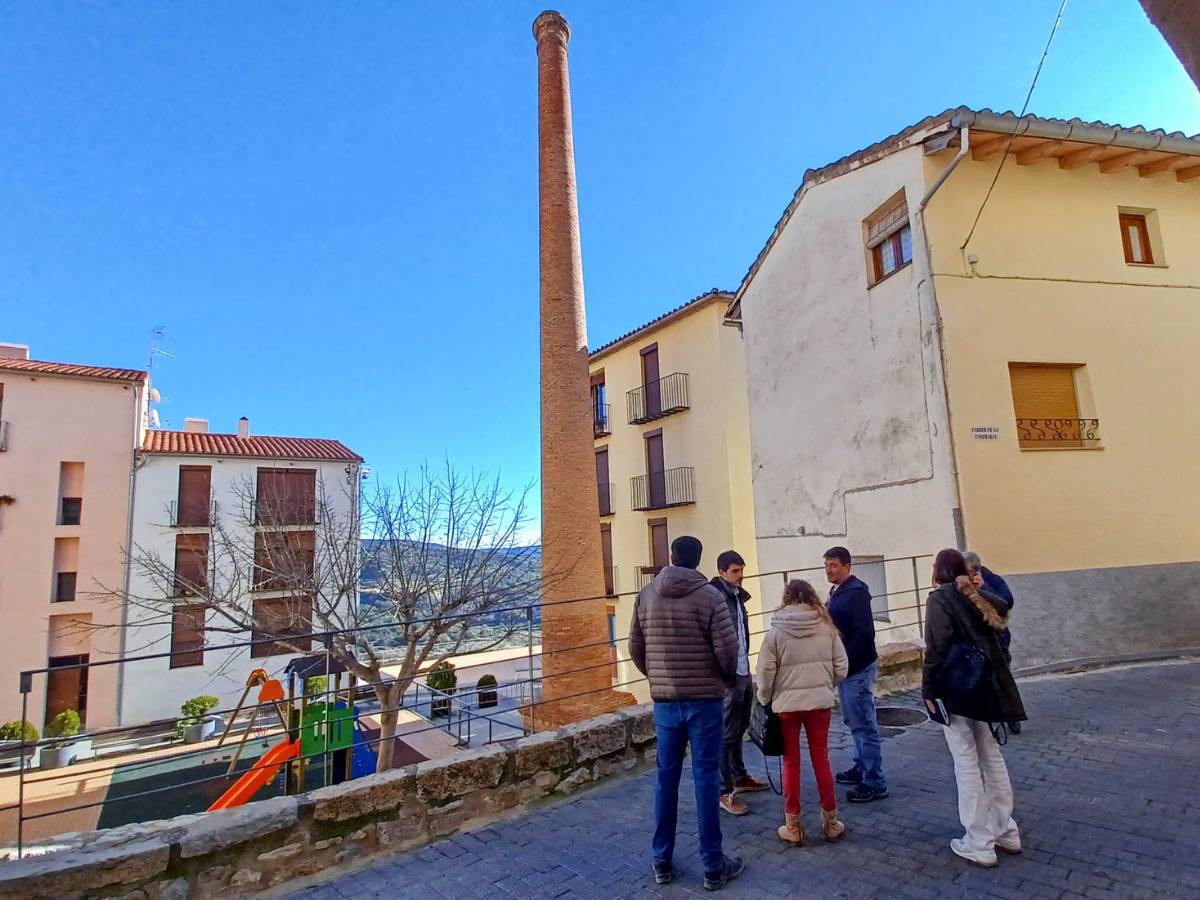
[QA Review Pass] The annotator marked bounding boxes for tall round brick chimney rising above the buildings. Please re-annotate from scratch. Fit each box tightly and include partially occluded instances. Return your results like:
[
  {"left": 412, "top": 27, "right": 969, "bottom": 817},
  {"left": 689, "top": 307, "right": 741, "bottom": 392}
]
[{"left": 532, "top": 11, "right": 631, "bottom": 728}]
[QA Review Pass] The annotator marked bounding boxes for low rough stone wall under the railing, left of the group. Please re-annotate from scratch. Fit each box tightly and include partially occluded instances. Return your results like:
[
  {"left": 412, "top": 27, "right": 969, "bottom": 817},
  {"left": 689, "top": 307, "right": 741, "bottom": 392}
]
[{"left": 0, "top": 704, "right": 654, "bottom": 900}]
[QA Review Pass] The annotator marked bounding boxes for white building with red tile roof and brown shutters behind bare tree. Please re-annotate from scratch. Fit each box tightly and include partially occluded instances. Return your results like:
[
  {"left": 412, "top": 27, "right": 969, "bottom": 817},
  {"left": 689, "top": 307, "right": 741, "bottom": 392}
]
[{"left": 118, "top": 419, "right": 362, "bottom": 725}]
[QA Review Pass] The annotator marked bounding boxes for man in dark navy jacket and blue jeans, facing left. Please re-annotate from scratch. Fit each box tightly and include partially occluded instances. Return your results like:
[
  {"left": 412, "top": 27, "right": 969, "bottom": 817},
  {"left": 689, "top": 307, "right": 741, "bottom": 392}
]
[{"left": 824, "top": 547, "right": 888, "bottom": 803}]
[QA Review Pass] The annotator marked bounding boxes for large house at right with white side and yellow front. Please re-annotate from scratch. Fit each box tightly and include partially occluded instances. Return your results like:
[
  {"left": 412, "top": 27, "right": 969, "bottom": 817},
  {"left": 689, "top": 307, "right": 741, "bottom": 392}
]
[{"left": 728, "top": 108, "right": 1200, "bottom": 665}]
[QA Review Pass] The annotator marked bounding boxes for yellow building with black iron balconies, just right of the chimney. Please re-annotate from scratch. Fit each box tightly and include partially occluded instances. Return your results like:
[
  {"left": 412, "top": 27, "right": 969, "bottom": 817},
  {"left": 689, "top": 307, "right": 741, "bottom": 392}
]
[{"left": 590, "top": 290, "right": 758, "bottom": 701}]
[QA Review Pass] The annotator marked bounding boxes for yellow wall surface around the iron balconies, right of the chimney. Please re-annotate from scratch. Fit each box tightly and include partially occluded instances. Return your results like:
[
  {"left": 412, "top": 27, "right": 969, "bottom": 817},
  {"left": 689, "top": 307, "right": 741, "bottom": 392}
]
[{"left": 592, "top": 299, "right": 758, "bottom": 701}]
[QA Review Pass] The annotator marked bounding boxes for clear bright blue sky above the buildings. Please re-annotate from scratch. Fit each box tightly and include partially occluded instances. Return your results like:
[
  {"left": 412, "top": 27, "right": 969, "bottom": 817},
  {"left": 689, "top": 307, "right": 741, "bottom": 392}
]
[{"left": 0, "top": 0, "right": 1200, "bottom": 525}]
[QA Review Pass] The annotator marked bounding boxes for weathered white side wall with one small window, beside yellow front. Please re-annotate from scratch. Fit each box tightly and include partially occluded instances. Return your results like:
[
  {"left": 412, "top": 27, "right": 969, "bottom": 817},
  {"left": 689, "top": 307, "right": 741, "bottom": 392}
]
[{"left": 742, "top": 146, "right": 956, "bottom": 642}]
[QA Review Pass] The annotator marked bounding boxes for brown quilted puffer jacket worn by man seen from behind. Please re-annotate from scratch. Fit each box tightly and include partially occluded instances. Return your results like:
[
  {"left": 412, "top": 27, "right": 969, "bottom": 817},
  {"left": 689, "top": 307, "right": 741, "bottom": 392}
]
[{"left": 629, "top": 565, "right": 738, "bottom": 700}]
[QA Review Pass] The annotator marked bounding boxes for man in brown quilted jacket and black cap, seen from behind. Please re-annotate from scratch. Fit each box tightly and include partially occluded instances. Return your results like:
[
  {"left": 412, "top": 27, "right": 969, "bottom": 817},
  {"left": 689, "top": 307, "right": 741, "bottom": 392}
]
[{"left": 629, "top": 536, "right": 745, "bottom": 890}]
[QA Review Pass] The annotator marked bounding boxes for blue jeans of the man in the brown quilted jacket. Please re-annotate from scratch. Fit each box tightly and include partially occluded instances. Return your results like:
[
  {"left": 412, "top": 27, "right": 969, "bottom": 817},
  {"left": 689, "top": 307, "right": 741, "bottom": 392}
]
[{"left": 653, "top": 698, "right": 724, "bottom": 872}]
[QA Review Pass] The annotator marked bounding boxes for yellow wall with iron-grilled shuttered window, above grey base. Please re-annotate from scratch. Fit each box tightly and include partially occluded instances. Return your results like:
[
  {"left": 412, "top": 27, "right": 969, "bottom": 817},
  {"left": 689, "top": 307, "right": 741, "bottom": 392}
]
[{"left": 925, "top": 146, "right": 1200, "bottom": 572}]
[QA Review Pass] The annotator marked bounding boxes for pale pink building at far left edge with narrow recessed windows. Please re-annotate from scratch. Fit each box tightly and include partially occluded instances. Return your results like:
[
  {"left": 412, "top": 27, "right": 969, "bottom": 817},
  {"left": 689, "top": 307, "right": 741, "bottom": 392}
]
[{"left": 0, "top": 344, "right": 149, "bottom": 732}]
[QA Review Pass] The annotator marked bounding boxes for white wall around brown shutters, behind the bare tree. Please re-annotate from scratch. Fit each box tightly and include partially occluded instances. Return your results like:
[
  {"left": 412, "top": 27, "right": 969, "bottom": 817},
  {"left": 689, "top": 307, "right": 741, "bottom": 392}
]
[{"left": 120, "top": 454, "right": 359, "bottom": 725}]
